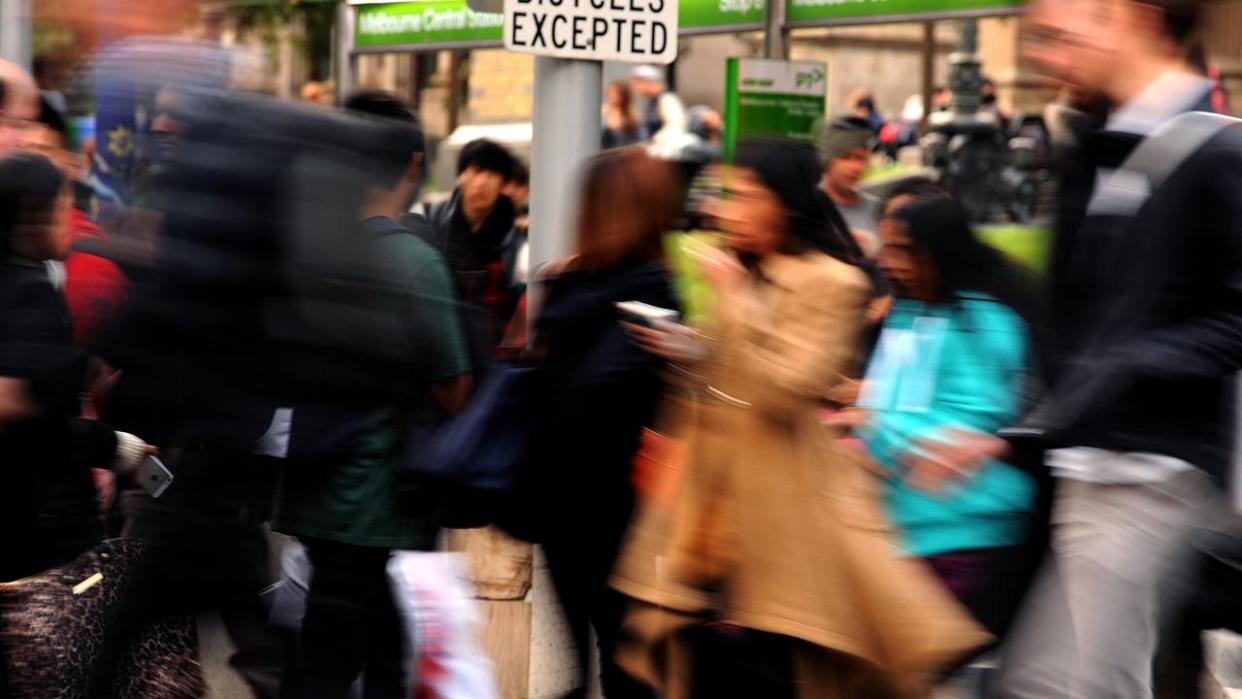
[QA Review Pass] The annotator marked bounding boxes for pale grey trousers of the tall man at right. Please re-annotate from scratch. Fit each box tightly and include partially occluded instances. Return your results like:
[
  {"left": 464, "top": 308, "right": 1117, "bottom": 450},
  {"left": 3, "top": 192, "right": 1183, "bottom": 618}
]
[{"left": 994, "top": 471, "right": 1216, "bottom": 699}]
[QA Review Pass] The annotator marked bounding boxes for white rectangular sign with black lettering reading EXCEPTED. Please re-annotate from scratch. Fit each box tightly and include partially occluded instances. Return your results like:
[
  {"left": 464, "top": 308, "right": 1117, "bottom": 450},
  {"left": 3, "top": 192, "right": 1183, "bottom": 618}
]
[{"left": 504, "top": 0, "right": 677, "bottom": 63}]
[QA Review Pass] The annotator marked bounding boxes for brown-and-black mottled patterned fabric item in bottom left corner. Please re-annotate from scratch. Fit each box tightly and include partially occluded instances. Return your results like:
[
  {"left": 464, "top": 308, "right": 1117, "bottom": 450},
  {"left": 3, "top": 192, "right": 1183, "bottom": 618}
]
[{"left": 0, "top": 539, "right": 206, "bottom": 699}]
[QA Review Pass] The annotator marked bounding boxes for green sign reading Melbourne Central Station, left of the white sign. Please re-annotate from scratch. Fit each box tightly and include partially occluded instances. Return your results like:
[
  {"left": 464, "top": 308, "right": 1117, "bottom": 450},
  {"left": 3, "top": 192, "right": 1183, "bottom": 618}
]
[{"left": 354, "top": 0, "right": 504, "bottom": 50}]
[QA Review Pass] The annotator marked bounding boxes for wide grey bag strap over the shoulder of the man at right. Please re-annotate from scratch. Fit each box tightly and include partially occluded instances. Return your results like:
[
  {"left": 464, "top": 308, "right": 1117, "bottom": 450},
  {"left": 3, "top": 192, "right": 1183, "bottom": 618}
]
[{"left": 1087, "top": 112, "right": 1242, "bottom": 216}]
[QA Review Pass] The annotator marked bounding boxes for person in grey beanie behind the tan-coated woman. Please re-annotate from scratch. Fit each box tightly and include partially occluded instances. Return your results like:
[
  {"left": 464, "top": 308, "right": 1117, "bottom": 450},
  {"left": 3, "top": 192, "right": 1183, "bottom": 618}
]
[{"left": 815, "top": 117, "right": 881, "bottom": 257}]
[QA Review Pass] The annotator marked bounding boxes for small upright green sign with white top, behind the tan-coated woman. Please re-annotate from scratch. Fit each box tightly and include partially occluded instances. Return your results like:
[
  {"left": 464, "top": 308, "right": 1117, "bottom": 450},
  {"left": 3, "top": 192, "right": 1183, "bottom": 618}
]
[{"left": 724, "top": 58, "right": 828, "bottom": 159}]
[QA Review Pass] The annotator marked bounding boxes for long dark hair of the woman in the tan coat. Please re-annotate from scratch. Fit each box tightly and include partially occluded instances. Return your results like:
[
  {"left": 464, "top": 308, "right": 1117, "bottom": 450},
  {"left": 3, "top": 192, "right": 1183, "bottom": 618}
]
[{"left": 733, "top": 138, "right": 857, "bottom": 264}]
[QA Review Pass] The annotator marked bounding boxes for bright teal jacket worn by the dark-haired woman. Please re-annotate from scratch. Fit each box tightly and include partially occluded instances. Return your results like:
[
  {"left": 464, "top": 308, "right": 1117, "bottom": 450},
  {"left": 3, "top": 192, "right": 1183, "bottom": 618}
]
[{"left": 859, "top": 293, "right": 1035, "bottom": 556}]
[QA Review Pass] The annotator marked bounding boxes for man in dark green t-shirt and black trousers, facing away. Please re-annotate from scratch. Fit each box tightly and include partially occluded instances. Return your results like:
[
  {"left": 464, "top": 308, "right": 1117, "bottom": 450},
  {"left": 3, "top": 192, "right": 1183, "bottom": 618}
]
[{"left": 273, "top": 92, "right": 471, "bottom": 699}]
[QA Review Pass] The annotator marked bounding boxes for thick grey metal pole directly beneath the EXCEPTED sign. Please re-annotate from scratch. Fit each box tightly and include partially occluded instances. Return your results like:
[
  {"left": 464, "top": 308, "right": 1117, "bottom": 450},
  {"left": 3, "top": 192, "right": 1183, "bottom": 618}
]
[{"left": 530, "top": 56, "right": 602, "bottom": 269}]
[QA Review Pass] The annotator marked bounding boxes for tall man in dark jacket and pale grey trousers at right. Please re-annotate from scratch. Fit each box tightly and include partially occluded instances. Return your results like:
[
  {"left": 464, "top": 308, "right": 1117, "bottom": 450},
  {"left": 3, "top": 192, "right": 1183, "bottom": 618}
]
[{"left": 915, "top": 5, "right": 1242, "bottom": 699}]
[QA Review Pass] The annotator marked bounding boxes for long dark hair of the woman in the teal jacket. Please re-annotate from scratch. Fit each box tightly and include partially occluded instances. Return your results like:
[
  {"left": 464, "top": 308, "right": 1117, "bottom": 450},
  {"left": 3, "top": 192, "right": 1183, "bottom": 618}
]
[{"left": 886, "top": 183, "right": 1043, "bottom": 329}]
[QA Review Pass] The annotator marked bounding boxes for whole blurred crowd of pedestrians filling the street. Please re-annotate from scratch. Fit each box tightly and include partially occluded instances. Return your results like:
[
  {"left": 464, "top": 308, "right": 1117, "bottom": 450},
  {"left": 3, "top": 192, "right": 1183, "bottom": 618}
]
[{"left": 0, "top": 0, "right": 1242, "bottom": 699}]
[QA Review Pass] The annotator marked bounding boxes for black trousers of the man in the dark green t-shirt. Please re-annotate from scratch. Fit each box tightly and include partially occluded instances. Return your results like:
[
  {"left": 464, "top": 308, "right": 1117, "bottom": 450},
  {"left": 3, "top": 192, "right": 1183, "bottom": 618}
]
[{"left": 281, "top": 539, "right": 405, "bottom": 699}]
